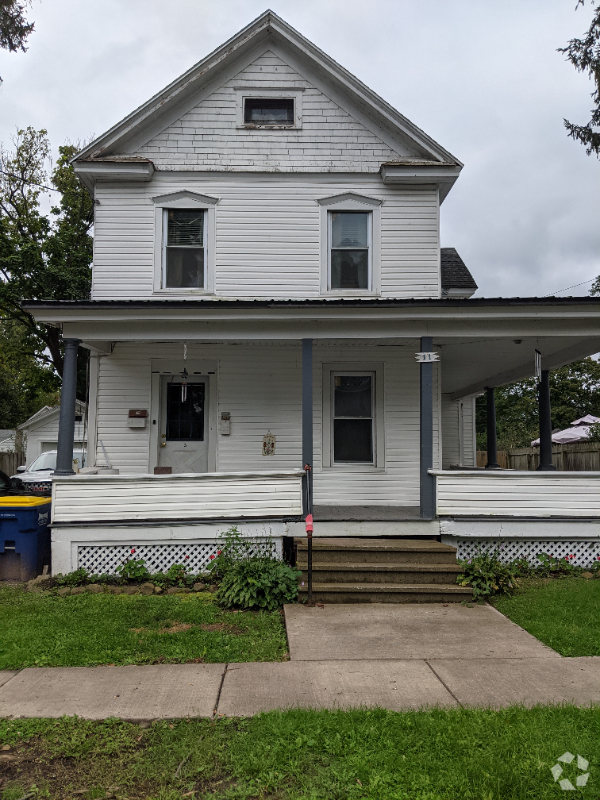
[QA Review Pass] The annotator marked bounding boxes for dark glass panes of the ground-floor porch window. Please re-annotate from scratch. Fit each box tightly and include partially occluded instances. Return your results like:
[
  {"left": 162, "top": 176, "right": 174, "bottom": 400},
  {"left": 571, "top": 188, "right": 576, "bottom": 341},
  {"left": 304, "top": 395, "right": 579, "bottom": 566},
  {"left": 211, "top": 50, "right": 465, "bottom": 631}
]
[{"left": 333, "top": 375, "right": 374, "bottom": 464}]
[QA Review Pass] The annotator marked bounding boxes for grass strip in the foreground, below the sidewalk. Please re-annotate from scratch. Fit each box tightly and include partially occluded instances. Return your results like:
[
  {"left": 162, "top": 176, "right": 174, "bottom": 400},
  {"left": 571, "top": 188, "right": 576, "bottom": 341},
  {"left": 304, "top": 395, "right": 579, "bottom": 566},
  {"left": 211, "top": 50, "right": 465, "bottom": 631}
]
[{"left": 0, "top": 706, "right": 600, "bottom": 800}]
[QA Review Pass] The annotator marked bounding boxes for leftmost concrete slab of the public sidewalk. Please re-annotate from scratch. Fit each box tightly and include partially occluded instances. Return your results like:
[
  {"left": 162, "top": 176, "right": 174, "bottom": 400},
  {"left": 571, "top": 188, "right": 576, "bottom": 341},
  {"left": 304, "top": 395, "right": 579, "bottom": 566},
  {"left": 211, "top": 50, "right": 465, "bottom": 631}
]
[{"left": 0, "top": 664, "right": 225, "bottom": 722}]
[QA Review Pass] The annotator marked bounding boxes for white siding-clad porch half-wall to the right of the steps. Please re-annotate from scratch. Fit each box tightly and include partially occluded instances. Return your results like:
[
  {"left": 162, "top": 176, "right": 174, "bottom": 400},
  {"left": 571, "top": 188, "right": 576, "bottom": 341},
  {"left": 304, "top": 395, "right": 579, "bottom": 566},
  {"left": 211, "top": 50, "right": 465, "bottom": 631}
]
[{"left": 434, "top": 470, "right": 600, "bottom": 517}]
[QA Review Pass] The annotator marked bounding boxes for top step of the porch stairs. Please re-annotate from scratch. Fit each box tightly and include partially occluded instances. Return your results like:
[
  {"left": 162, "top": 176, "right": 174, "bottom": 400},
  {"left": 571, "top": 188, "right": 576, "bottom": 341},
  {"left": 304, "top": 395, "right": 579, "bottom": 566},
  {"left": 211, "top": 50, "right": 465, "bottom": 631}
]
[{"left": 294, "top": 538, "right": 456, "bottom": 566}]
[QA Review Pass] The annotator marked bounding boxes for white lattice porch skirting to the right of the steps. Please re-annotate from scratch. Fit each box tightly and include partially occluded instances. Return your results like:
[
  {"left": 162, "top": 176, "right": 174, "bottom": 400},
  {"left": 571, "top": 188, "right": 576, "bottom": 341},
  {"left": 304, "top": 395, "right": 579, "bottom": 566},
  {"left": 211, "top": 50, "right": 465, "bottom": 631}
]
[{"left": 442, "top": 536, "right": 600, "bottom": 567}]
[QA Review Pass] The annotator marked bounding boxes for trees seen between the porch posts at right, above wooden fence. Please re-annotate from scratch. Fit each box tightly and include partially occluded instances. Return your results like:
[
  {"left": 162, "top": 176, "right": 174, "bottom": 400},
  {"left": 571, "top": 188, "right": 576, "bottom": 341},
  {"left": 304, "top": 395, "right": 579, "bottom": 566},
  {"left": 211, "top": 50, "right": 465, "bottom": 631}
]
[{"left": 477, "top": 358, "right": 600, "bottom": 450}]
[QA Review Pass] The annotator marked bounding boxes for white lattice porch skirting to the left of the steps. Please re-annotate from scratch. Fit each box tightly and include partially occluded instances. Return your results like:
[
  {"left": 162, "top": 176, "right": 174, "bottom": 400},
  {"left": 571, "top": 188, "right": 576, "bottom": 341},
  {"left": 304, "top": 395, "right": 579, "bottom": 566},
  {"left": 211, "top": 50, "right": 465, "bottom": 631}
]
[{"left": 77, "top": 538, "right": 283, "bottom": 575}]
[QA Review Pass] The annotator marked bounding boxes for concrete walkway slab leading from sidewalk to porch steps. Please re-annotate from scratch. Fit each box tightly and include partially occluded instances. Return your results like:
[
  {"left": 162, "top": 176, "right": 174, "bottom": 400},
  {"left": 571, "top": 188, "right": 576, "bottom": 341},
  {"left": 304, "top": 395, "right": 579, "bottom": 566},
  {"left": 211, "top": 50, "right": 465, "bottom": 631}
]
[{"left": 284, "top": 603, "right": 560, "bottom": 661}]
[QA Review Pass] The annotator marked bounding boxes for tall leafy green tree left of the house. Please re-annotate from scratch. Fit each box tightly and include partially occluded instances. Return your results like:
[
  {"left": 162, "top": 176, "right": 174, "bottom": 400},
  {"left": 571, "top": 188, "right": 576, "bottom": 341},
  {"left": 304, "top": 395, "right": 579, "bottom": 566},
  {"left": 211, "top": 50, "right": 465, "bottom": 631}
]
[{"left": 0, "top": 128, "right": 94, "bottom": 382}]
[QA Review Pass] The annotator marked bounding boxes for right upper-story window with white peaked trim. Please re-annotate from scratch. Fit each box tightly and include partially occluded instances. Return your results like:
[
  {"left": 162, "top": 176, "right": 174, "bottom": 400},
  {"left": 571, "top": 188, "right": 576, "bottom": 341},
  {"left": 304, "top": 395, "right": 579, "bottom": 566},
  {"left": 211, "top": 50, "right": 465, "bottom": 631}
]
[{"left": 317, "top": 192, "right": 382, "bottom": 296}]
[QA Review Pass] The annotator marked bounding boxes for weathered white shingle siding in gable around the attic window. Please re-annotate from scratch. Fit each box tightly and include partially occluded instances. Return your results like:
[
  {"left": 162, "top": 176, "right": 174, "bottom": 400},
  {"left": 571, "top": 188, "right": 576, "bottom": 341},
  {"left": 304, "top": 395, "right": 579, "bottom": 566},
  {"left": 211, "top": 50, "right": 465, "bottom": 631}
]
[{"left": 137, "top": 51, "right": 414, "bottom": 172}]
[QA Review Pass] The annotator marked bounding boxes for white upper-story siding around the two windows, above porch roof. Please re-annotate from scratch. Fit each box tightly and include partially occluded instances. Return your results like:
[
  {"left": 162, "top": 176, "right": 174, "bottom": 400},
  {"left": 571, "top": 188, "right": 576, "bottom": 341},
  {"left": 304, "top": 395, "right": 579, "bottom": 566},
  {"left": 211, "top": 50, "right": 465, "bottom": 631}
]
[{"left": 92, "top": 172, "right": 439, "bottom": 300}]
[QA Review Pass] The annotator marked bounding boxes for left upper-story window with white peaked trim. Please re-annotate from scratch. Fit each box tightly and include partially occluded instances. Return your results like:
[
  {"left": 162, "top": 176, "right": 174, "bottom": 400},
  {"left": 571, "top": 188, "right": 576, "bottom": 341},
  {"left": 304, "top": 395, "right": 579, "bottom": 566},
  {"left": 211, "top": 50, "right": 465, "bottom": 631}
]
[{"left": 152, "top": 190, "right": 218, "bottom": 295}]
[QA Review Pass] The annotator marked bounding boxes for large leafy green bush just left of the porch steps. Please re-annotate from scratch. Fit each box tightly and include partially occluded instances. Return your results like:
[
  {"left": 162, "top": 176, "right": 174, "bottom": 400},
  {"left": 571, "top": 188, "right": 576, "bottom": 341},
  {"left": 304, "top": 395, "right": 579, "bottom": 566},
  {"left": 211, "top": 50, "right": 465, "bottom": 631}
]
[{"left": 217, "top": 556, "right": 301, "bottom": 611}]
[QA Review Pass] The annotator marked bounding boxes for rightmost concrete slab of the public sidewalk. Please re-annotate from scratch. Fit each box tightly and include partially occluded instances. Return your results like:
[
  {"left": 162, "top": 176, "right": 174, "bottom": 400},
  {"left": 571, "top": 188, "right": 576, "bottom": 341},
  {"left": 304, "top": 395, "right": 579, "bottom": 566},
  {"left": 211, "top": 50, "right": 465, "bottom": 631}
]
[{"left": 430, "top": 657, "right": 600, "bottom": 708}]
